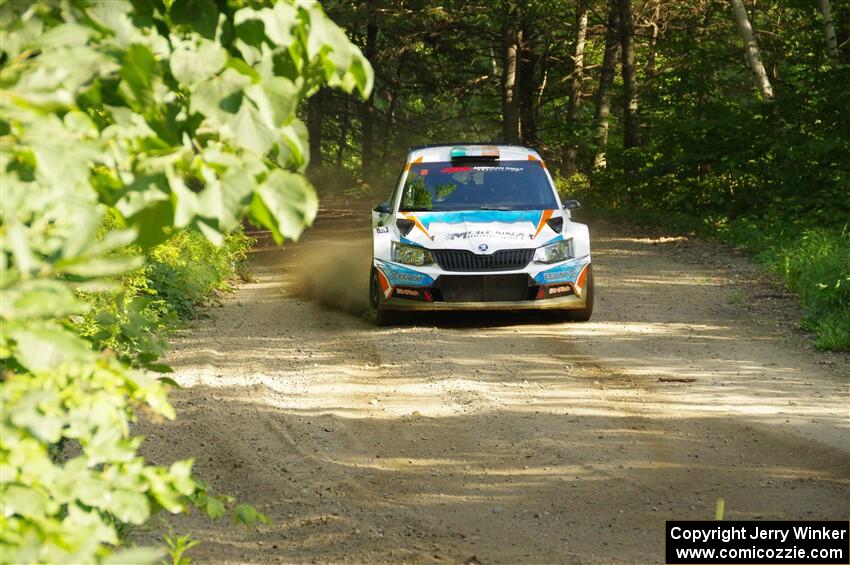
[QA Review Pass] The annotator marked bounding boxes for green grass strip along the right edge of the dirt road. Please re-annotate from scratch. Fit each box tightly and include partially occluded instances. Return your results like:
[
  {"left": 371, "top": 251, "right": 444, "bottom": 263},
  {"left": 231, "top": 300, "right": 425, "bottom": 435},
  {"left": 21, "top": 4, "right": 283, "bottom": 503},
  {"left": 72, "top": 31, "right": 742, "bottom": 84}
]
[{"left": 558, "top": 178, "right": 850, "bottom": 351}]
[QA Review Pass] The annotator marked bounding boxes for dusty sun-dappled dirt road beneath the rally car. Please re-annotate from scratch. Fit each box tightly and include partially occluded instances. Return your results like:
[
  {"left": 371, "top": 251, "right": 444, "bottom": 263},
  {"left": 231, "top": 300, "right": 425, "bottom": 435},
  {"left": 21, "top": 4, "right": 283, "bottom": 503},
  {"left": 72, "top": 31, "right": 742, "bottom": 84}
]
[{"left": 136, "top": 200, "right": 850, "bottom": 564}]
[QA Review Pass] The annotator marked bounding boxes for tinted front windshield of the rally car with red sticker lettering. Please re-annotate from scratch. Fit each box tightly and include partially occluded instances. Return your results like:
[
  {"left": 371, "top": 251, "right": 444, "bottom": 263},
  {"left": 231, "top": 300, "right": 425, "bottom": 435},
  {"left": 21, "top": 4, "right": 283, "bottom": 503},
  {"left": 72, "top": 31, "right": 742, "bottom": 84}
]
[{"left": 399, "top": 161, "right": 558, "bottom": 212}]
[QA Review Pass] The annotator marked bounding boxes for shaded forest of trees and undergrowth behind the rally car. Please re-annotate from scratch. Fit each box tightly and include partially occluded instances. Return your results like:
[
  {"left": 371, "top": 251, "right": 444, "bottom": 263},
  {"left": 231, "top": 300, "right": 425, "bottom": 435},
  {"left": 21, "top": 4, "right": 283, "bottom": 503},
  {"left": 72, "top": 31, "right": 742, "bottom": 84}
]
[{"left": 304, "top": 0, "right": 850, "bottom": 349}]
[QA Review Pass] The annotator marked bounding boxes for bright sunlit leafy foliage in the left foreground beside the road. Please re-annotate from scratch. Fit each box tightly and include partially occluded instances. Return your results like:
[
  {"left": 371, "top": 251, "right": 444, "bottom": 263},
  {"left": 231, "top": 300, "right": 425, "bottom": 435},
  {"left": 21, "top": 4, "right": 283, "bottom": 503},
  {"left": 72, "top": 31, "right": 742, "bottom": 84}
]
[{"left": 0, "top": 0, "right": 371, "bottom": 563}]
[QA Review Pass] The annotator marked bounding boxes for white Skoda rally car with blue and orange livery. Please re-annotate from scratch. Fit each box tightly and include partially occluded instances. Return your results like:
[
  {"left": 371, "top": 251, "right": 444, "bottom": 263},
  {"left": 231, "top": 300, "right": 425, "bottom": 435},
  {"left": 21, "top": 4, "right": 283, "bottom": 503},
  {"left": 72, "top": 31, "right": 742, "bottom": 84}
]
[{"left": 369, "top": 144, "right": 593, "bottom": 324}]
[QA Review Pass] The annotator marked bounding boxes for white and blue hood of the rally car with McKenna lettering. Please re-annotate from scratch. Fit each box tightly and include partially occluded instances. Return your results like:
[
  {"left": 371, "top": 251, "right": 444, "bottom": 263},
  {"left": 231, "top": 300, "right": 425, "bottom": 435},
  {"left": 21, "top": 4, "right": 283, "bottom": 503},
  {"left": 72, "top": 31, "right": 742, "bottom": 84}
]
[{"left": 399, "top": 210, "right": 563, "bottom": 254}]
